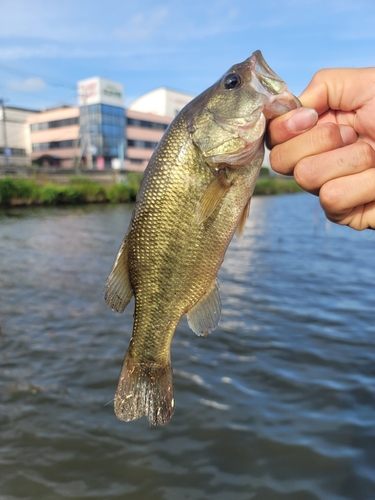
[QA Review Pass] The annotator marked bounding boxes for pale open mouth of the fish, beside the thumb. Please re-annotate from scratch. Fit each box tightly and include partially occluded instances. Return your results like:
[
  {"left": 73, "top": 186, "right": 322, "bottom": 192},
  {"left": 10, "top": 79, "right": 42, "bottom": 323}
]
[{"left": 248, "top": 50, "right": 302, "bottom": 120}]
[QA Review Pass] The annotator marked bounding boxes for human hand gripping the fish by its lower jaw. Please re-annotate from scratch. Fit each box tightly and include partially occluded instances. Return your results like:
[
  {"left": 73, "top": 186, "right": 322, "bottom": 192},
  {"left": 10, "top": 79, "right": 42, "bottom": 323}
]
[{"left": 267, "top": 68, "right": 375, "bottom": 230}]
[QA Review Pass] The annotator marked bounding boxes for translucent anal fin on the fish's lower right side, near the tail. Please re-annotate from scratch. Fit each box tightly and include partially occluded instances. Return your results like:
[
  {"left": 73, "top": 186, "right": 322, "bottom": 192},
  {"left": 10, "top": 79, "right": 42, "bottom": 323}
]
[{"left": 186, "top": 279, "right": 221, "bottom": 336}]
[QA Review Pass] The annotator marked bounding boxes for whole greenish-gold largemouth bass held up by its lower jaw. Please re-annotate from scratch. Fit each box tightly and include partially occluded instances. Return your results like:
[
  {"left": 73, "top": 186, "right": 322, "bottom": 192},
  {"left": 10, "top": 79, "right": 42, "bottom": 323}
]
[{"left": 105, "top": 51, "right": 300, "bottom": 425}]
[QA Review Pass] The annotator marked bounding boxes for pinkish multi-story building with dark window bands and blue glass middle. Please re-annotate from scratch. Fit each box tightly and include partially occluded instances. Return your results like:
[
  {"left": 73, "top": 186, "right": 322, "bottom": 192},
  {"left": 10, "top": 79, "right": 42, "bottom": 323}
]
[{"left": 29, "top": 104, "right": 172, "bottom": 170}]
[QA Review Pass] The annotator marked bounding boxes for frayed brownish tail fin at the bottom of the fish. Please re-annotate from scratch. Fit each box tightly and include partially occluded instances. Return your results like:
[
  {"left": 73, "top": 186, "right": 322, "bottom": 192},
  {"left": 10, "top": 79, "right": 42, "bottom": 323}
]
[{"left": 115, "top": 354, "right": 174, "bottom": 425}]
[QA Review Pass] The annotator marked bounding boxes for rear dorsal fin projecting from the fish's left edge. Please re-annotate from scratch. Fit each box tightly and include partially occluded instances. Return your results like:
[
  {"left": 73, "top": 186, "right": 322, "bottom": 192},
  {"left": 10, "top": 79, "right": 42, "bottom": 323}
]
[{"left": 104, "top": 237, "right": 133, "bottom": 313}]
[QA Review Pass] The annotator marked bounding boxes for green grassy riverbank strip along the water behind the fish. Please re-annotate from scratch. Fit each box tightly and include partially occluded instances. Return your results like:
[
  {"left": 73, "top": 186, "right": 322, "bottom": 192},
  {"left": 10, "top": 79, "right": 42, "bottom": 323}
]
[{"left": 0, "top": 173, "right": 301, "bottom": 206}]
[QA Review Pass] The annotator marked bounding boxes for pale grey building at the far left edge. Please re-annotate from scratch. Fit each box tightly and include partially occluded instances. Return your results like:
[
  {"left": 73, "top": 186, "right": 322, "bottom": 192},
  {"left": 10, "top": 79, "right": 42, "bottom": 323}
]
[{"left": 0, "top": 106, "right": 38, "bottom": 166}]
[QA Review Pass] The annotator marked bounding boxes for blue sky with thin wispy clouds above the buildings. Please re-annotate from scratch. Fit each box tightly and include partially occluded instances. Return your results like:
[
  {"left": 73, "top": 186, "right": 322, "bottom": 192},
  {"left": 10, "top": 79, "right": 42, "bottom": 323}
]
[{"left": 0, "top": 0, "right": 375, "bottom": 109}]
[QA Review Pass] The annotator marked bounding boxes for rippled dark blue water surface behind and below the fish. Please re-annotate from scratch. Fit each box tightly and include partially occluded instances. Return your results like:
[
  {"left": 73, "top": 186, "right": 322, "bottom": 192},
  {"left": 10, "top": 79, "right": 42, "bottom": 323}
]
[{"left": 0, "top": 195, "right": 375, "bottom": 500}]
